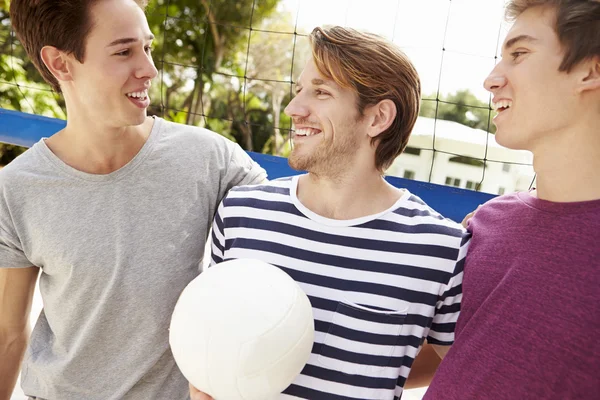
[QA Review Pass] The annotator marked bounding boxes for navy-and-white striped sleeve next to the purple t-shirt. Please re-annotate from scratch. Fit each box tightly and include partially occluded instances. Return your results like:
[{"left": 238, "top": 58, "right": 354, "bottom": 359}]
[{"left": 427, "top": 232, "right": 471, "bottom": 346}]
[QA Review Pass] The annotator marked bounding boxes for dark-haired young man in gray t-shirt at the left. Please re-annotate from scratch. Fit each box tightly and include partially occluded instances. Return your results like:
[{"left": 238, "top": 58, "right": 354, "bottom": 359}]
[{"left": 0, "top": 0, "right": 266, "bottom": 400}]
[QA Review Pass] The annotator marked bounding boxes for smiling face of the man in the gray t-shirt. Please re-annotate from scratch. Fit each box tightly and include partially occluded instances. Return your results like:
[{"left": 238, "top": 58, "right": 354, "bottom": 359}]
[{"left": 63, "top": 0, "right": 157, "bottom": 127}]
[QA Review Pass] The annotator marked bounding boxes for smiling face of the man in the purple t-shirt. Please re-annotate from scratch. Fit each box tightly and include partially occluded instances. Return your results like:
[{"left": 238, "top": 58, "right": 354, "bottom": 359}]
[{"left": 485, "top": 7, "right": 577, "bottom": 150}]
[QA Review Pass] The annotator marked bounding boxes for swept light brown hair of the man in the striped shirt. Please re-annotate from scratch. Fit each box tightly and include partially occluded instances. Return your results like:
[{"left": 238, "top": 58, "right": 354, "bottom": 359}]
[{"left": 309, "top": 26, "right": 421, "bottom": 172}]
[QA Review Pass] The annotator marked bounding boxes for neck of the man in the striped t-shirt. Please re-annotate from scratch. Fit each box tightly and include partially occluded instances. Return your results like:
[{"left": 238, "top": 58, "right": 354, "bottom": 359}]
[{"left": 297, "top": 162, "right": 402, "bottom": 220}]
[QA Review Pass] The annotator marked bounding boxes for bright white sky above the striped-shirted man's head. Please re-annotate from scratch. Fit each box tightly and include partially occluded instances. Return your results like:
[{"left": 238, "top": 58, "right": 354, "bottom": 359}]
[{"left": 282, "top": 0, "right": 510, "bottom": 102}]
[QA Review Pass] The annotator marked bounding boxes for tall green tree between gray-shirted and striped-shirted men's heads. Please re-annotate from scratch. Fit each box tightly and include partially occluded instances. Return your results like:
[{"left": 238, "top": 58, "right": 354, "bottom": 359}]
[{"left": 147, "top": 0, "right": 279, "bottom": 125}]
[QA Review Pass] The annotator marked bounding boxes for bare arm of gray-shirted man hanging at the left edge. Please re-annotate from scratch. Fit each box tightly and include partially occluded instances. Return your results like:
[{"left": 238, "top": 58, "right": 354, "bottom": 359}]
[{"left": 0, "top": 267, "right": 39, "bottom": 400}]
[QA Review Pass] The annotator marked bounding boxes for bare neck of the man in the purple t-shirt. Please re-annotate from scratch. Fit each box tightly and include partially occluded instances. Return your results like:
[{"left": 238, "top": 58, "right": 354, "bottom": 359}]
[{"left": 533, "top": 118, "right": 600, "bottom": 202}]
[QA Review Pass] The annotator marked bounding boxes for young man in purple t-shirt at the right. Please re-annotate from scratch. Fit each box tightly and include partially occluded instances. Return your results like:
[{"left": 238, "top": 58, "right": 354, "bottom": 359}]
[{"left": 425, "top": 0, "right": 600, "bottom": 400}]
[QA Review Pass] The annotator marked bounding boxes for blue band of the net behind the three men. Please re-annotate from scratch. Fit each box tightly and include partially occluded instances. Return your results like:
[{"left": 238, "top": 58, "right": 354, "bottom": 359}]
[{"left": 0, "top": 108, "right": 494, "bottom": 222}]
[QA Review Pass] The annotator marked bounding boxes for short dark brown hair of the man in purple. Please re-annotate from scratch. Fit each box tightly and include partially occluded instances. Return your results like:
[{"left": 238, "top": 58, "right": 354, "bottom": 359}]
[{"left": 506, "top": 0, "right": 600, "bottom": 72}]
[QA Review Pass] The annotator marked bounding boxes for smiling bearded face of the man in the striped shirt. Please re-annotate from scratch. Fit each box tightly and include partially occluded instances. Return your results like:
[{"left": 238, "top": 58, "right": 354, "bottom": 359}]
[{"left": 285, "top": 60, "right": 369, "bottom": 175}]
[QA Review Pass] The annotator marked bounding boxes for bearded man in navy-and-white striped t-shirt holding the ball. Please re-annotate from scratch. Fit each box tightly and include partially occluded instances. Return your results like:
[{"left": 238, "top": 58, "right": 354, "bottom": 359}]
[{"left": 192, "top": 27, "right": 468, "bottom": 400}]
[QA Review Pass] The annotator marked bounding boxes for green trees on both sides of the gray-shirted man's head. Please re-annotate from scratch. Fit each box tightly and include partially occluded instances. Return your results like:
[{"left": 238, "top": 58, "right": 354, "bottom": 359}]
[{"left": 0, "top": 0, "right": 286, "bottom": 159}]
